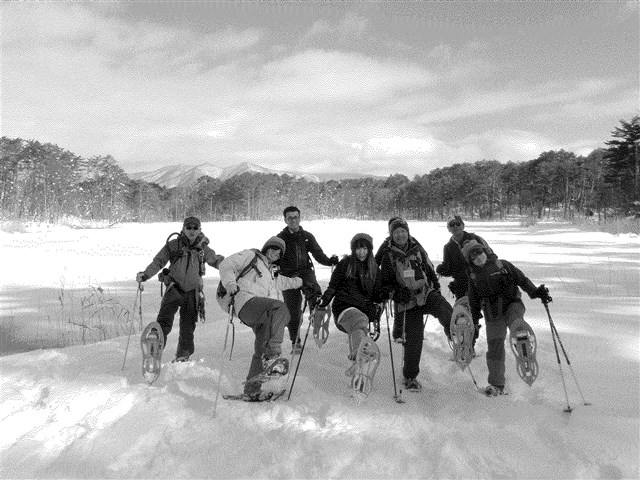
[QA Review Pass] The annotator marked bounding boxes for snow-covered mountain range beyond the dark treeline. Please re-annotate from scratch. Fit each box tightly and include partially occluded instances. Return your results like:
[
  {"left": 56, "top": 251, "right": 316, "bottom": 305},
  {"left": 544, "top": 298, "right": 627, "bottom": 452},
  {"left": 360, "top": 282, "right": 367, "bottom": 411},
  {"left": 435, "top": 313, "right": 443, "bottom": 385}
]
[{"left": 129, "top": 162, "right": 319, "bottom": 188}]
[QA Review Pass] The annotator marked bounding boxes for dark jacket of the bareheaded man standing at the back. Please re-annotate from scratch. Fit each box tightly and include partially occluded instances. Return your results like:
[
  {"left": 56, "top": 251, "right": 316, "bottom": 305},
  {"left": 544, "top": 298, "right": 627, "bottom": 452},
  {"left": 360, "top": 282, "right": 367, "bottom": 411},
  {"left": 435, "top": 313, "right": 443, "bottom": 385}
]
[{"left": 277, "top": 227, "right": 331, "bottom": 277}]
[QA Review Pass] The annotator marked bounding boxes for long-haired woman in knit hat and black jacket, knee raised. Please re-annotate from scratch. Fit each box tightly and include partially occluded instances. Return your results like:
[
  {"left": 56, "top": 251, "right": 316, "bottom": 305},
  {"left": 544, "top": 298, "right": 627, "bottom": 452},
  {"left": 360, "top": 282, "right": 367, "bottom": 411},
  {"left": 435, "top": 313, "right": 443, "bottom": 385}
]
[{"left": 319, "top": 233, "right": 388, "bottom": 361}]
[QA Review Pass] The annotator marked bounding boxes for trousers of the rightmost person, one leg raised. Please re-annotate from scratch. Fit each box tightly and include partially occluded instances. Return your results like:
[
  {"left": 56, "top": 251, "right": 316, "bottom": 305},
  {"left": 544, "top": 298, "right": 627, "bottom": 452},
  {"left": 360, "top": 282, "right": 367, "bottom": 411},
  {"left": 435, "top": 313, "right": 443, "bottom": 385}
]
[{"left": 485, "top": 302, "right": 527, "bottom": 387}]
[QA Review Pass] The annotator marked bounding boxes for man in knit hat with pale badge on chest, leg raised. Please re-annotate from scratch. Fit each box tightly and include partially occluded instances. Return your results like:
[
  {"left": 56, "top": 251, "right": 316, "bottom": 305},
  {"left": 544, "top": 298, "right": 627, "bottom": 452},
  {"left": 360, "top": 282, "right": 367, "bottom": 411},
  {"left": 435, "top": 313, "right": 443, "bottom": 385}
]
[{"left": 381, "top": 219, "right": 453, "bottom": 390}]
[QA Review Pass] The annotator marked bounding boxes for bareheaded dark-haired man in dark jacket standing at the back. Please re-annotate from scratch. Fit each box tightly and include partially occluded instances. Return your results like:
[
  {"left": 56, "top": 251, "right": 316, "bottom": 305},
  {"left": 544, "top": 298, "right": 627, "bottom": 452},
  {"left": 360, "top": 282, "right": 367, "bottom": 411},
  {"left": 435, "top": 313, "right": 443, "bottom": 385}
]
[{"left": 277, "top": 206, "right": 338, "bottom": 352}]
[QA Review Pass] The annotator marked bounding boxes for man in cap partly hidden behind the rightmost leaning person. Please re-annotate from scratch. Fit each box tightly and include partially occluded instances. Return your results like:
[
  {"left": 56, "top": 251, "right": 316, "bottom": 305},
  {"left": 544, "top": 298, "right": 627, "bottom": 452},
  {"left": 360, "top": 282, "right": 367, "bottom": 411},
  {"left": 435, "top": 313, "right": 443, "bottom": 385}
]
[{"left": 436, "top": 215, "right": 498, "bottom": 347}]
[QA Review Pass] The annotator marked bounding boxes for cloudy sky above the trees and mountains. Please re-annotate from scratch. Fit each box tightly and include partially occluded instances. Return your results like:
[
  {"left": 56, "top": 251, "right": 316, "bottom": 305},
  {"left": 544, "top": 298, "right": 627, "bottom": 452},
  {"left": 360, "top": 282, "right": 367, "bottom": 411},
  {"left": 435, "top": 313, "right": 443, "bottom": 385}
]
[{"left": 1, "top": 1, "right": 640, "bottom": 177}]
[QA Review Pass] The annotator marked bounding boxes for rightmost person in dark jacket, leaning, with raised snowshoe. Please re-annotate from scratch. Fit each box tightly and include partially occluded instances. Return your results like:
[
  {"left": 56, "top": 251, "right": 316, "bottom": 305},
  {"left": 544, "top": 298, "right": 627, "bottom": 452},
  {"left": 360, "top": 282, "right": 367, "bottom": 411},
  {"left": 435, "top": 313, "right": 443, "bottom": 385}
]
[{"left": 462, "top": 240, "right": 551, "bottom": 396}]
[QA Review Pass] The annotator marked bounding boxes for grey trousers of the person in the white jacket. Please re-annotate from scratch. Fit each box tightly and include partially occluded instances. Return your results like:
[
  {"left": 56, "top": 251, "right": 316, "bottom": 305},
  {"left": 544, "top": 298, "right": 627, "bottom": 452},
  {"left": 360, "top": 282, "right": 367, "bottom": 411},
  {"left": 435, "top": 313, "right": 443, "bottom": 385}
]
[{"left": 238, "top": 297, "right": 289, "bottom": 394}]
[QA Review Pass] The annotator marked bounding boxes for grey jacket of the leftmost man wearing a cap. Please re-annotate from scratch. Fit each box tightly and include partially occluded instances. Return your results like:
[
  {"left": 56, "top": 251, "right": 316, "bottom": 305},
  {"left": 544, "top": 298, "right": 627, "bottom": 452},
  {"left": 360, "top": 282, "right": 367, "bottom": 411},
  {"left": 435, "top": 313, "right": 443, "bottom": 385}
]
[{"left": 143, "top": 233, "right": 224, "bottom": 292}]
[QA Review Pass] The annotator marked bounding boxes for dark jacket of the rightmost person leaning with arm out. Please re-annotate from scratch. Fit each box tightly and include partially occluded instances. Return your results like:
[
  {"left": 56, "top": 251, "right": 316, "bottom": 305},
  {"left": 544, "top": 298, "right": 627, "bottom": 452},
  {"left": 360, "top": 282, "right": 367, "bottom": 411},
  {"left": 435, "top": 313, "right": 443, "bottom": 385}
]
[{"left": 468, "top": 260, "right": 536, "bottom": 322}]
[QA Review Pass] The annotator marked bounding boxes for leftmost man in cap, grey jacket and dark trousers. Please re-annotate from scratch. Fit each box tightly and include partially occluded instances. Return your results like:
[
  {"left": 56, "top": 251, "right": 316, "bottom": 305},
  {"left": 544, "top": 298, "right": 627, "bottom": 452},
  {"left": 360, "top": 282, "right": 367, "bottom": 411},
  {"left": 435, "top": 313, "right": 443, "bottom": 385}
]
[{"left": 136, "top": 217, "right": 224, "bottom": 362}]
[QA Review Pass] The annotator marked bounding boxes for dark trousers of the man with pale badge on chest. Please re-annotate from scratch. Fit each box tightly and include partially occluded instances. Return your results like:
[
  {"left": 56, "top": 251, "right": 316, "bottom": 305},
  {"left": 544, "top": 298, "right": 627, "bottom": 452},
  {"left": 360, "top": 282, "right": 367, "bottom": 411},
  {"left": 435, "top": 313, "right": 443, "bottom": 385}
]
[{"left": 395, "top": 290, "right": 453, "bottom": 378}]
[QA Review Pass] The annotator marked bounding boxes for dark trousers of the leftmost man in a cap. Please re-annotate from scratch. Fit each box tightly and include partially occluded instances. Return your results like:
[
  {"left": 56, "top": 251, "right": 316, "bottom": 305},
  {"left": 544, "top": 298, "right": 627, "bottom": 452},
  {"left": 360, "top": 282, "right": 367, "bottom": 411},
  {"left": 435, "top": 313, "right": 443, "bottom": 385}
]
[{"left": 157, "top": 284, "right": 198, "bottom": 357}]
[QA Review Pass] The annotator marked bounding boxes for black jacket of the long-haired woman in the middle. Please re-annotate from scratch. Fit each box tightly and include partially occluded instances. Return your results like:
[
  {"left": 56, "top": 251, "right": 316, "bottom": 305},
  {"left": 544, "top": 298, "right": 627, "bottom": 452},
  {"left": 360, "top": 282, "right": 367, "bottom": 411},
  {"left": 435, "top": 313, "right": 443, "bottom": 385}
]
[{"left": 322, "top": 256, "right": 385, "bottom": 322}]
